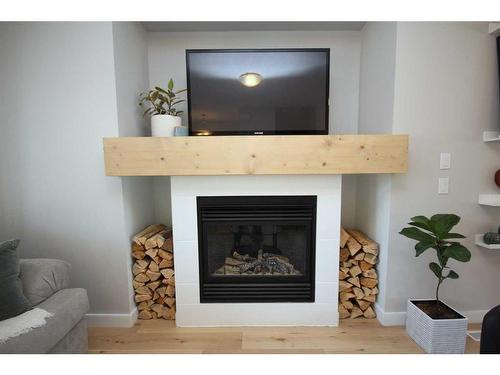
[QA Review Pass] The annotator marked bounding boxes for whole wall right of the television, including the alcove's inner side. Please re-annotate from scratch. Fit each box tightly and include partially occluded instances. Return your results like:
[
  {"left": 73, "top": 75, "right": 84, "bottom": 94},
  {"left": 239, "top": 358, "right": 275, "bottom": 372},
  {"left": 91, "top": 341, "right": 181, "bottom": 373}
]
[{"left": 357, "top": 23, "right": 500, "bottom": 324}]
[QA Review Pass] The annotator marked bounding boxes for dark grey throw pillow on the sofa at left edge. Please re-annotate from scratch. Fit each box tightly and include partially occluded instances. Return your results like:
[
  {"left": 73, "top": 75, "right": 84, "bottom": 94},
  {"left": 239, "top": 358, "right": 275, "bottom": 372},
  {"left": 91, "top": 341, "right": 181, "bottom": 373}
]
[{"left": 0, "top": 240, "right": 31, "bottom": 320}]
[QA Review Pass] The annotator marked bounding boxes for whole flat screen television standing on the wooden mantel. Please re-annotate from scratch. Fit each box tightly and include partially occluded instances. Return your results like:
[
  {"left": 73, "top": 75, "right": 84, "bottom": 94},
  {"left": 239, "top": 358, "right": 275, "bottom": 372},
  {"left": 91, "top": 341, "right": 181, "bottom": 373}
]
[{"left": 186, "top": 48, "right": 330, "bottom": 135}]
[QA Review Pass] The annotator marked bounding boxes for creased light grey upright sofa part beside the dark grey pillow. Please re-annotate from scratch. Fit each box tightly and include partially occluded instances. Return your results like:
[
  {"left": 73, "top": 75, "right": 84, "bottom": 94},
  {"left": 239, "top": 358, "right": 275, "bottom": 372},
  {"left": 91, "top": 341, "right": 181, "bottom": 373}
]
[{"left": 20, "top": 259, "right": 71, "bottom": 306}]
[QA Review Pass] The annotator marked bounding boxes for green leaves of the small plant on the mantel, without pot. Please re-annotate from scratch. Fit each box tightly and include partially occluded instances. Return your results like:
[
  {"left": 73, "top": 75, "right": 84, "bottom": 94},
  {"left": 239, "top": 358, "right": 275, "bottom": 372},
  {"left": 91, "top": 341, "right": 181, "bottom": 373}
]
[{"left": 139, "top": 78, "right": 187, "bottom": 116}]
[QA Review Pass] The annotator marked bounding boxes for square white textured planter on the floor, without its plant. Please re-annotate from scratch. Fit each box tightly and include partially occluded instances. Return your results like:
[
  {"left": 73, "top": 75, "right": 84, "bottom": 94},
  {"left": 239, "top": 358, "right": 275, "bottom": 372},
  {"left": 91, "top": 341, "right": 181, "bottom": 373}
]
[{"left": 406, "top": 300, "right": 467, "bottom": 354}]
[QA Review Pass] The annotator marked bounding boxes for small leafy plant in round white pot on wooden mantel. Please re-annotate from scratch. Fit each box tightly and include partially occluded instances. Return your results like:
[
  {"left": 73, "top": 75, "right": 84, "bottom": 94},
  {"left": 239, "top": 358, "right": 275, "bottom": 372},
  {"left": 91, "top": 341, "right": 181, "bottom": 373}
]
[{"left": 139, "top": 78, "right": 187, "bottom": 137}]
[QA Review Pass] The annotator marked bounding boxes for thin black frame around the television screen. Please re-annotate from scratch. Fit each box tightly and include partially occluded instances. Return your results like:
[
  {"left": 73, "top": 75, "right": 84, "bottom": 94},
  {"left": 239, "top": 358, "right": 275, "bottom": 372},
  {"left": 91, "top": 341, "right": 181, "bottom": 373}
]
[{"left": 186, "top": 48, "right": 330, "bottom": 136}]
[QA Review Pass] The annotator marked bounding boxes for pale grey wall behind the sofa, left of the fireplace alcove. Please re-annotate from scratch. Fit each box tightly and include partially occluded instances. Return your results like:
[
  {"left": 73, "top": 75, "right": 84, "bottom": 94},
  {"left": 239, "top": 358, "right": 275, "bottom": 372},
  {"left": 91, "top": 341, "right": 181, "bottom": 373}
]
[{"left": 0, "top": 23, "right": 136, "bottom": 313}]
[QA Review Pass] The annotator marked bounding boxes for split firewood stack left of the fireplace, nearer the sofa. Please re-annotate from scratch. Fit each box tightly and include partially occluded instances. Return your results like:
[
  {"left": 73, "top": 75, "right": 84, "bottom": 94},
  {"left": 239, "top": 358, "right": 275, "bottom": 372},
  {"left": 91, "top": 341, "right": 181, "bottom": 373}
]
[{"left": 132, "top": 224, "right": 175, "bottom": 320}]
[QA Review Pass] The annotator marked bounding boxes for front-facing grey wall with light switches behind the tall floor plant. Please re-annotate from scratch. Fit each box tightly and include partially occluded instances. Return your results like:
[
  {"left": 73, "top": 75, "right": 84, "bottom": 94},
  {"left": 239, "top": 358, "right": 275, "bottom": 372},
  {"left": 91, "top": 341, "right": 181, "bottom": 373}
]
[{"left": 385, "top": 23, "right": 500, "bottom": 311}]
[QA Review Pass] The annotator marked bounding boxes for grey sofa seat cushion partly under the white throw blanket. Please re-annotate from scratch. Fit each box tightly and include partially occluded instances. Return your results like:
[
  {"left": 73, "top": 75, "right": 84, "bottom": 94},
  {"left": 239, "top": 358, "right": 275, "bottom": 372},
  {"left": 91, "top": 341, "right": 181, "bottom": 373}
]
[{"left": 0, "top": 288, "right": 89, "bottom": 353}]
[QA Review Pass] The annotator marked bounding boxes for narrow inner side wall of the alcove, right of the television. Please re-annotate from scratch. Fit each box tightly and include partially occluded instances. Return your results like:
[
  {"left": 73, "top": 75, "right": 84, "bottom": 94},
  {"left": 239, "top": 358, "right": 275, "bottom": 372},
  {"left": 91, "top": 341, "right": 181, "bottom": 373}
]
[{"left": 355, "top": 22, "right": 397, "bottom": 318}]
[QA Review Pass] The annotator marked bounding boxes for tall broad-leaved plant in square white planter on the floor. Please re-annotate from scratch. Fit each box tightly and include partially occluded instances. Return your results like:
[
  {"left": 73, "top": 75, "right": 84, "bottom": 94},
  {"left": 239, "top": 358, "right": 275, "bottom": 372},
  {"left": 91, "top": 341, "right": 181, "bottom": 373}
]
[{"left": 399, "top": 214, "right": 471, "bottom": 353}]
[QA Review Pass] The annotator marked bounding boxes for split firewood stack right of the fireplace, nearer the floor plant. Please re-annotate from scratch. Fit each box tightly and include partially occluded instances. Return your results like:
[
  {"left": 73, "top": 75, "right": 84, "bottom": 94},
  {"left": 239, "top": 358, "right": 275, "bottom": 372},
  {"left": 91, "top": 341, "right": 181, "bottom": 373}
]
[{"left": 339, "top": 228, "right": 378, "bottom": 319}]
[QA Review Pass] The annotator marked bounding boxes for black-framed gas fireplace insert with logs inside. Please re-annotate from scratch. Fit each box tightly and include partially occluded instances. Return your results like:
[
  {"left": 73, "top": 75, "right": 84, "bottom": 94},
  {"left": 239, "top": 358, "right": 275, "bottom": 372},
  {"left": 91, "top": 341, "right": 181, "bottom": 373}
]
[{"left": 197, "top": 196, "right": 317, "bottom": 303}]
